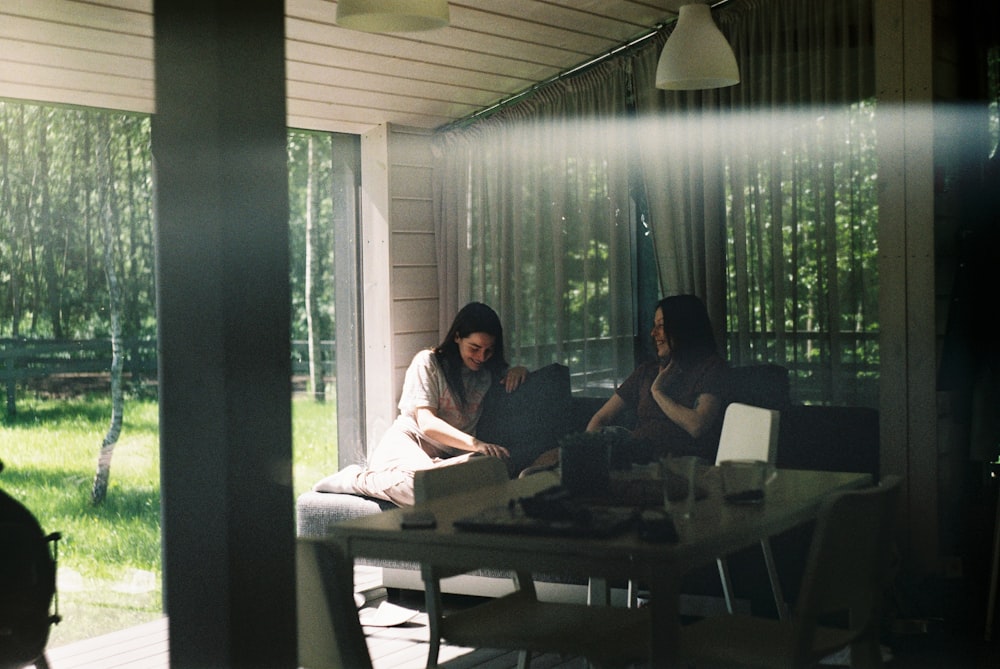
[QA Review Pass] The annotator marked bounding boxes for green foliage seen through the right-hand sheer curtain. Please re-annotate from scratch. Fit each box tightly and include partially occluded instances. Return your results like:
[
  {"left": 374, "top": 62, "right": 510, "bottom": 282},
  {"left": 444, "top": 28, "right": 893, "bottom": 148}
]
[{"left": 726, "top": 100, "right": 880, "bottom": 404}]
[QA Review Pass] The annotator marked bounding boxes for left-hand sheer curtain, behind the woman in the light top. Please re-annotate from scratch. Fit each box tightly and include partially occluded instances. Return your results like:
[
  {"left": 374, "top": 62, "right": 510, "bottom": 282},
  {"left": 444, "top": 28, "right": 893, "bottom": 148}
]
[{"left": 435, "top": 61, "right": 634, "bottom": 389}]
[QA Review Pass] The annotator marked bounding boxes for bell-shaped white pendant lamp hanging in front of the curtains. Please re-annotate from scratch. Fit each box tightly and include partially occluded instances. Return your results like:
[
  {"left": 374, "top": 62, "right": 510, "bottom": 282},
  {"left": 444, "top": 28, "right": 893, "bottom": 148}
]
[{"left": 656, "top": 4, "right": 740, "bottom": 91}]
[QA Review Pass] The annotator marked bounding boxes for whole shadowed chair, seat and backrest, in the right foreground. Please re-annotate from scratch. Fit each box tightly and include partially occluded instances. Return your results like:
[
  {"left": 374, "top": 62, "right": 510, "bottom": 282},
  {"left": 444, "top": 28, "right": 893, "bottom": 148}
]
[{"left": 679, "top": 476, "right": 900, "bottom": 669}]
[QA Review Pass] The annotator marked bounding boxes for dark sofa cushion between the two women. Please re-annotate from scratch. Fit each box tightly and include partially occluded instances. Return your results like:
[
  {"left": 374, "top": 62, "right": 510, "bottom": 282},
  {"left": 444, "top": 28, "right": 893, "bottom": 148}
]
[{"left": 476, "top": 363, "right": 572, "bottom": 475}]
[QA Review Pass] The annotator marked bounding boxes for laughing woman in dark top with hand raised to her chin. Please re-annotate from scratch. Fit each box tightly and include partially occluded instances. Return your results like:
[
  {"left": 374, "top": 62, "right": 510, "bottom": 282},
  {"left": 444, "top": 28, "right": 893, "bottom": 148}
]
[{"left": 587, "top": 295, "right": 728, "bottom": 462}]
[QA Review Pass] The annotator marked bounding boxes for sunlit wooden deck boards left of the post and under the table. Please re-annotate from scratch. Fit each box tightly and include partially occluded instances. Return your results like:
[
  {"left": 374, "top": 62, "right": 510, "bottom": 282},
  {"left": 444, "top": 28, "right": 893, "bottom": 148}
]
[{"left": 37, "top": 567, "right": 586, "bottom": 669}]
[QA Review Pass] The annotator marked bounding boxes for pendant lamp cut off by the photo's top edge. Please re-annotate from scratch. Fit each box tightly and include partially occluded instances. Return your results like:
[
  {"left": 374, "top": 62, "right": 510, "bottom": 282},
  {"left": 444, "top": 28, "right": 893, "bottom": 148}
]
[{"left": 337, "top": 0, "right": 449, "bottom": 33}]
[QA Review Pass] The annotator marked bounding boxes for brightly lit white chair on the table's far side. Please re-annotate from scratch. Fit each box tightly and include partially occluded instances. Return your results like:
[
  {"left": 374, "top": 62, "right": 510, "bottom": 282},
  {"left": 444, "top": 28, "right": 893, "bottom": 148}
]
[{"left": 715, "top": 402, "right": 788, "bottom": 620}]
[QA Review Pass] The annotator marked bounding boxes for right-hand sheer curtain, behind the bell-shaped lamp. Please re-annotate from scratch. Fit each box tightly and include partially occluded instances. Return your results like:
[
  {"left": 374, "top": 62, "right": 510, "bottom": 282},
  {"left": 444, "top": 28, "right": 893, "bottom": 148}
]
[{"left": 635, "top": 0, "right": 878, "bottom": 406}]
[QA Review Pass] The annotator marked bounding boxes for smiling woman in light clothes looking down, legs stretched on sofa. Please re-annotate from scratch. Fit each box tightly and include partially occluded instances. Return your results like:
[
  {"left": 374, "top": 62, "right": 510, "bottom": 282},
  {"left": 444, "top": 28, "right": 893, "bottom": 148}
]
[{"left": 313, "top": 302, "right": 528, "bottom": 506}]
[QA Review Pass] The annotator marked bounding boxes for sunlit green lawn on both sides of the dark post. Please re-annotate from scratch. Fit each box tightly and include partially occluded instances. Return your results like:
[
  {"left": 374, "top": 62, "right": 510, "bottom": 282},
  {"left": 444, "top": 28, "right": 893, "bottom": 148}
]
[{"left": 0, "top": 394, "right": 337, "bottom": 647}]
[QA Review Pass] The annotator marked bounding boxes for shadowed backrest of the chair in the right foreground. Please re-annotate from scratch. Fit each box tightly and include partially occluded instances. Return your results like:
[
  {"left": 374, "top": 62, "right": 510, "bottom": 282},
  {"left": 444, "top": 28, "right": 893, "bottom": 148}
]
[{"left": 795, "top": 475, "right": 900, "bottom": 658}]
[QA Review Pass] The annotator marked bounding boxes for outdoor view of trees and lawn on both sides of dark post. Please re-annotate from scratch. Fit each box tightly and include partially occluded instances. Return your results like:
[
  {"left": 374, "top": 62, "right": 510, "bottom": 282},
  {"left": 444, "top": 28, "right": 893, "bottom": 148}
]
[{"left": 0, "top": 100, "right": 344, "bottom": 647}]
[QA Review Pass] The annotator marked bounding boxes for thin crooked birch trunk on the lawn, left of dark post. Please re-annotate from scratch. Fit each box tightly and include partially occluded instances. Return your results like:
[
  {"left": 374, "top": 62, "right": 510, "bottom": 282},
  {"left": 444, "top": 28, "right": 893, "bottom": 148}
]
[{"left": 90, "top": 116, "right": 125, "bottom": 504}]
